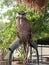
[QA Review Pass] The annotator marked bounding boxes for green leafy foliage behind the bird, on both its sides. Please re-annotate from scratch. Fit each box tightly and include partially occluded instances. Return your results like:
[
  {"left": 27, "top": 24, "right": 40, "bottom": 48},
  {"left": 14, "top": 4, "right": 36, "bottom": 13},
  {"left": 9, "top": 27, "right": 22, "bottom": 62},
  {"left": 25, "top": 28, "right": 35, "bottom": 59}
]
[{"left": 0, "top": 0, "right": 49, "bottom": 48}]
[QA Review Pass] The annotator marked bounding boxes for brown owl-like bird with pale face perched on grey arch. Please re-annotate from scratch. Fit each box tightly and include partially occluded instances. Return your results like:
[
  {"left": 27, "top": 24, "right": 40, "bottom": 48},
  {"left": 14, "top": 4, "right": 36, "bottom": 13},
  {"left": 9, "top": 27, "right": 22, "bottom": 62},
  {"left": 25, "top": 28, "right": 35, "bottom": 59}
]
[{"left": 16, "top": 11, "right": 32, "bottom": 64}]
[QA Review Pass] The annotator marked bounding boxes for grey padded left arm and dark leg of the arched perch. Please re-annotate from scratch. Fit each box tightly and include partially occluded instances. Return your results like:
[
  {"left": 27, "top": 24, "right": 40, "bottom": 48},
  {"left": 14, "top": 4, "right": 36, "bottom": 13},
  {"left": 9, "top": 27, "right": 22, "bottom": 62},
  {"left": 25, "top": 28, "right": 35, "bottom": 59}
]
[{"left": 8, "top": 39, "right": 21, "bottom": 65}]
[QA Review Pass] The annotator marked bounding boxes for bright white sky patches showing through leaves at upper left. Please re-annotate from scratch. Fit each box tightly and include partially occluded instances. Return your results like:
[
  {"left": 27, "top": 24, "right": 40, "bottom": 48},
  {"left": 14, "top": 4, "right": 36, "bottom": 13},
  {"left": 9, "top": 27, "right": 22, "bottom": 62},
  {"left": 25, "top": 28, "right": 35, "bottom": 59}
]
[{"left": 0, "top": 1, "right": 17, "bottom": 22}]
